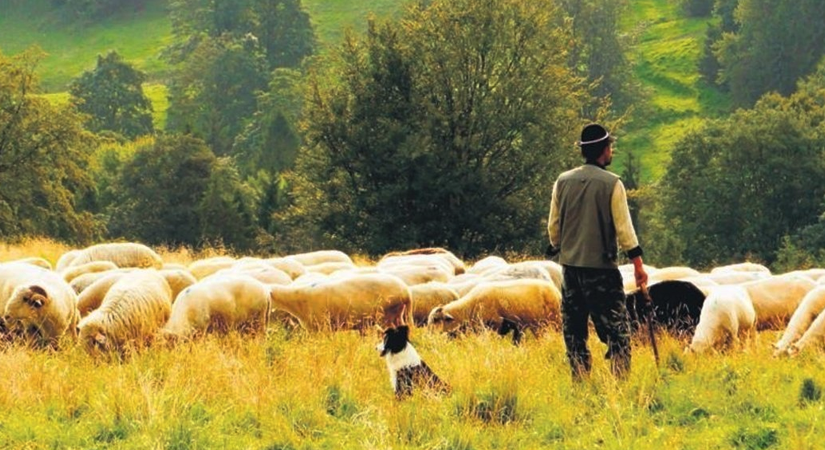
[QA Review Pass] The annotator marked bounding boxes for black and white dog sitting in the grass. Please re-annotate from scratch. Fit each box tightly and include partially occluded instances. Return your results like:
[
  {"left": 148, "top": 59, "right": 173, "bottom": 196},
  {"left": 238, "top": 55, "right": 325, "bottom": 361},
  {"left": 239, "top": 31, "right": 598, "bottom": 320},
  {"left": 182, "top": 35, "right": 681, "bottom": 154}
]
[{"left": 376, "top": 312, "right": 450, "bottom": 399}]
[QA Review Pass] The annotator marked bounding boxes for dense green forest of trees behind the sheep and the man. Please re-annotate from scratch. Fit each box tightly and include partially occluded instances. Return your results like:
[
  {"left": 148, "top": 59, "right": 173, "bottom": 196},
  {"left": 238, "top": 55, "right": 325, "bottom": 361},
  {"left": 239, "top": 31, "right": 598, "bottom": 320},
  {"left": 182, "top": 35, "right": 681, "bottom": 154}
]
[{"left": 0, "top": 0, "right": 825, "bottom": 271}]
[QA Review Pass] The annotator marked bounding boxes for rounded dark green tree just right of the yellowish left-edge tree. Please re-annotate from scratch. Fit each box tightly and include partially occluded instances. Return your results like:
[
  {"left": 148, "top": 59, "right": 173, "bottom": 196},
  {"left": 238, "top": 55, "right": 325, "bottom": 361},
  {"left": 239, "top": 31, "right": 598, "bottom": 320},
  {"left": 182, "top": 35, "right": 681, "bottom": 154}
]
[{"left": 109, "top": 134, "right": 215, "bottom": 246}]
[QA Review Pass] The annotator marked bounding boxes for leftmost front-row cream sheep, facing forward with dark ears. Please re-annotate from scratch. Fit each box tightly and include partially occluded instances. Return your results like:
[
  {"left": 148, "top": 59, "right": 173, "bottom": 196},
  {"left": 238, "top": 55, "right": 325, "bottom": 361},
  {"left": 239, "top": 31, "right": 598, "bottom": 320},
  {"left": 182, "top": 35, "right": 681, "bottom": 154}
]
[{"left": 0, "top": 263, "right": 79, "bottom": 345}]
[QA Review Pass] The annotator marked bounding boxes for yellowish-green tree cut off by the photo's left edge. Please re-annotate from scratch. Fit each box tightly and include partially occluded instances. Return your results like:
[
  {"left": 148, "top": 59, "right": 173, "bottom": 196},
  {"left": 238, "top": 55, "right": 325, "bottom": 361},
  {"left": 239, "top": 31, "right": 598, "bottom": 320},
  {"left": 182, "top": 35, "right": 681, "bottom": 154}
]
[{"left": 0, "top": 50, "right": 101, "bottom": 243}]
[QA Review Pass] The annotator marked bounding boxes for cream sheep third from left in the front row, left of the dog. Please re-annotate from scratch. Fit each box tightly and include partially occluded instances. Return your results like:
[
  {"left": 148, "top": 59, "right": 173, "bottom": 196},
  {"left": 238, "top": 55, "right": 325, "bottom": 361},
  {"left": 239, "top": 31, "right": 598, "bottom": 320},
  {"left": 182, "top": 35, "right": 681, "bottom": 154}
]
[{"left": 163, "top": 274, "right": 271, "bottom": 338}]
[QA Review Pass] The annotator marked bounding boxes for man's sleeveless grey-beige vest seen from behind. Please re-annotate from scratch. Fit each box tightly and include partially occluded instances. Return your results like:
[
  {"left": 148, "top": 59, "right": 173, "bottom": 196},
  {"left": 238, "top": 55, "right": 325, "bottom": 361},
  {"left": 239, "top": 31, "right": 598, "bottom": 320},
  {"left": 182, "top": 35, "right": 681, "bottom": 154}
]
[{"left": 556, "top": 164, "right": 619, "bottom": 269}]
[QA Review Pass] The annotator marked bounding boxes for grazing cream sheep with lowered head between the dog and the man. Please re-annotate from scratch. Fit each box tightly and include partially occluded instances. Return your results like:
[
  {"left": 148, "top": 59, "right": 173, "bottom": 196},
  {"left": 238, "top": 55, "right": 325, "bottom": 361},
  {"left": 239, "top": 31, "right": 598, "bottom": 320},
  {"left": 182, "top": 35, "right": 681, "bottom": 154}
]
[{"left": 427, "top": 278, "right": 561, "bottom": 343}]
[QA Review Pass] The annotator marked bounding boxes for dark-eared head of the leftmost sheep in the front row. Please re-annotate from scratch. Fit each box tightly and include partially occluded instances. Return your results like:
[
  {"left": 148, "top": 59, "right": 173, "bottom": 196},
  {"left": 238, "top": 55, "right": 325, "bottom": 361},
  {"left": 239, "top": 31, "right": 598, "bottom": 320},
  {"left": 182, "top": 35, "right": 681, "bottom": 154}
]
[{"left": 3, "top": 286, "right": 49, "bottom": 337}]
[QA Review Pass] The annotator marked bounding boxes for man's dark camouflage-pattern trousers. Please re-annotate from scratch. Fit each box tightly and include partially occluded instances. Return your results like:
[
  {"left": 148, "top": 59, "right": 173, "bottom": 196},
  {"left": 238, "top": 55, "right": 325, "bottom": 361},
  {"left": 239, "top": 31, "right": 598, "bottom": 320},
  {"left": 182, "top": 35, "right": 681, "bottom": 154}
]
[{"left": 561, "top": 266, "right": 630, "bottom": 380}]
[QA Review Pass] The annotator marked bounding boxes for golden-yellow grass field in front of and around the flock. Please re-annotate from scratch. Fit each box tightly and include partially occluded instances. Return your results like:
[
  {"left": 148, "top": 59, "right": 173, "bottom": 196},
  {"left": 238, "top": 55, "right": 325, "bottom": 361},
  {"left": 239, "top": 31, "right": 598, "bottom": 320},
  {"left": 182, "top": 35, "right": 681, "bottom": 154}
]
[{"left": 0, "top": 240, "right": 825, "bottom": 449}]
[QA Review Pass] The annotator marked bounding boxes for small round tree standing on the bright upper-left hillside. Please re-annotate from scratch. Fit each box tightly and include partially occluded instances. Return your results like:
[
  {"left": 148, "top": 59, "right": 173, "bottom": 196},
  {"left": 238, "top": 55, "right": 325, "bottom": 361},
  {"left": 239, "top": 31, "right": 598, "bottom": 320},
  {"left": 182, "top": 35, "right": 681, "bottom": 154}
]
[{"left": 69, "top": 51, "right": 154, "bottom": 139}]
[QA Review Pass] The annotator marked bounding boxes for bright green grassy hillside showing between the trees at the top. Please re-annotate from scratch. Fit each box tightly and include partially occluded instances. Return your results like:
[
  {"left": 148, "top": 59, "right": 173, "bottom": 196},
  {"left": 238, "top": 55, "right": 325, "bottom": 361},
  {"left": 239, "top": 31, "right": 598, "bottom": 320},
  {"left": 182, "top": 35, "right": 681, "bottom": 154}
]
[{"left": 0, "top": 0, "right": 727, "bottom": 181}]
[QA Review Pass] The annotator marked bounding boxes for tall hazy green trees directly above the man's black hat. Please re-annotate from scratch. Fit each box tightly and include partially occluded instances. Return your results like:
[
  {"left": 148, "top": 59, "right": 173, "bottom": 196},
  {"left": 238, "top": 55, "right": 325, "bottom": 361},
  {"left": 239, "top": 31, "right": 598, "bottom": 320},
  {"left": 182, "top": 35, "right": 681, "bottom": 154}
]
[{"left": 560, "top": 0, "right": 641, "bottom": 118}]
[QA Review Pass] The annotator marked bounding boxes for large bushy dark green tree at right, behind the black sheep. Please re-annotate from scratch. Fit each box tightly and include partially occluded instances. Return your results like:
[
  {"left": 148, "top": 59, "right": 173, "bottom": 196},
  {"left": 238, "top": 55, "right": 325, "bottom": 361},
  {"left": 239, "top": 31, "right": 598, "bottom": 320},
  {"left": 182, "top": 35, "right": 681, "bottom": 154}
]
[{"left": 661, "top": 92, "right": 825, "bottom": 266}]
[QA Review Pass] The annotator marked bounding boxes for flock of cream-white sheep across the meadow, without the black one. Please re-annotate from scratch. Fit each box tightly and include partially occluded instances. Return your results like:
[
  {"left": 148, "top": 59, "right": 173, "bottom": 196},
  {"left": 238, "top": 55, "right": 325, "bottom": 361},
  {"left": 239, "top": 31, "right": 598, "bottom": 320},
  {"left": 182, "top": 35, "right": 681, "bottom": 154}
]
[{"left": 0, "top": 243, "right": 825, "bottom": 354}]
